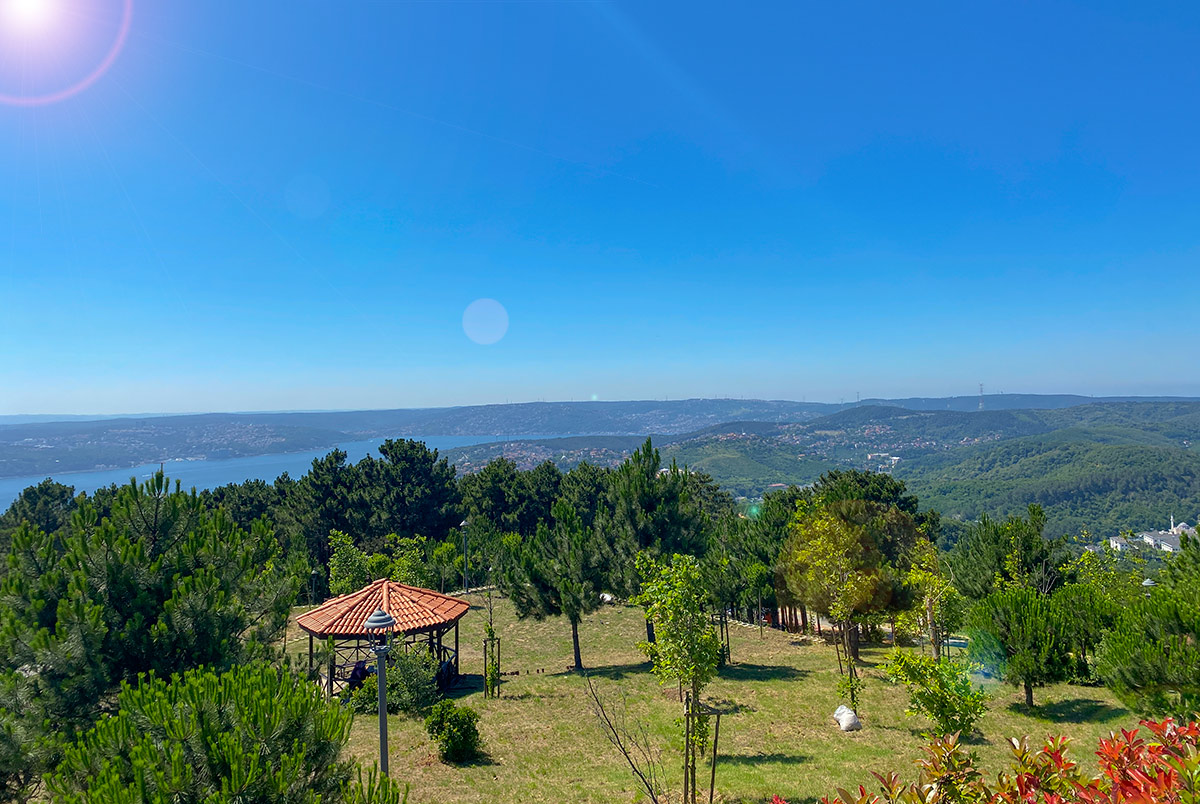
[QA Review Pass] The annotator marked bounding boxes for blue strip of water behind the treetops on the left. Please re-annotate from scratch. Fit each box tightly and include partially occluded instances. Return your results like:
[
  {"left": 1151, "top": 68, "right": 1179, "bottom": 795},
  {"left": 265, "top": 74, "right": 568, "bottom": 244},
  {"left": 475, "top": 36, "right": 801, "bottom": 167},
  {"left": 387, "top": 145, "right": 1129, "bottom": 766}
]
[{"left": 0, "top": 436, "right": 552, "bottom": 511}]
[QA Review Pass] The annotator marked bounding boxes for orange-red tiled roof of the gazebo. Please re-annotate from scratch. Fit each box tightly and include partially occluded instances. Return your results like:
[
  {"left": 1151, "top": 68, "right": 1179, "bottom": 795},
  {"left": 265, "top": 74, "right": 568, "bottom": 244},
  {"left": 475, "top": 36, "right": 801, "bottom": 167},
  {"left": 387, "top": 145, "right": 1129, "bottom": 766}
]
[{"left": 296, "top": 578, "right": 470, "bottom": 637}]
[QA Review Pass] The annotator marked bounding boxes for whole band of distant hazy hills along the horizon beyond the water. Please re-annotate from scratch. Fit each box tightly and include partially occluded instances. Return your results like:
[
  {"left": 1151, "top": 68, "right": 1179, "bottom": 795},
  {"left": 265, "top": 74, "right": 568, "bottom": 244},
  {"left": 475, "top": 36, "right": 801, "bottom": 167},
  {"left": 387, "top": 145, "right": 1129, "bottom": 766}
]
[{"left": 9, "top": 395, "right": 1200, "bottom": 534}]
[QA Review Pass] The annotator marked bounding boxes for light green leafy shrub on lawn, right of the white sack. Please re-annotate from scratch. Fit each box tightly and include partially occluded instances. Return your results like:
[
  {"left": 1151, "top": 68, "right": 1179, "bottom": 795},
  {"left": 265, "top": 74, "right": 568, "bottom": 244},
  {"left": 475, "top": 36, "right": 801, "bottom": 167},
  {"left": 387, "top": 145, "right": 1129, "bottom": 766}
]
[{"left": 884, "top": 650, "right": 988, "bottom": 734}]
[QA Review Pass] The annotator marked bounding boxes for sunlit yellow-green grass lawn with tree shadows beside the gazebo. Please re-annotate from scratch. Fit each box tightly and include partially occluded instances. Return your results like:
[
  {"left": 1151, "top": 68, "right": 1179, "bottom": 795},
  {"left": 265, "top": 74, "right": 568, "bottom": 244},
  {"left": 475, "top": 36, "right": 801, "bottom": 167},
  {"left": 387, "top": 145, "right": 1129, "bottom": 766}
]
[{"left": 321, "top": 594, "right": 1136, "bottom": 804}]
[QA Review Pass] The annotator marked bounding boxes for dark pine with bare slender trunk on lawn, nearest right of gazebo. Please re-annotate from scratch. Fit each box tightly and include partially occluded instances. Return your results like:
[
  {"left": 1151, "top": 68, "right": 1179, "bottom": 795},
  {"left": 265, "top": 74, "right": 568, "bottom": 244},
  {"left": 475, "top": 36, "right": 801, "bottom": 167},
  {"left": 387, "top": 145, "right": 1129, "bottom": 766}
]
[{"left": 502, "top": 499, "right": 604, "bottom": 668}]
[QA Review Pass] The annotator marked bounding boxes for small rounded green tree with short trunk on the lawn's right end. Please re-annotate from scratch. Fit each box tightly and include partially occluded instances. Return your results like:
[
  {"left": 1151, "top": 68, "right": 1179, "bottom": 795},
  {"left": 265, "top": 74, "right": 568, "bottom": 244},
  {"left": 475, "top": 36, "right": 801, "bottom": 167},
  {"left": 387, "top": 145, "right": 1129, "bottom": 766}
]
[{"left": 968, "top": 587, "right": 1070, "bottom": 707}]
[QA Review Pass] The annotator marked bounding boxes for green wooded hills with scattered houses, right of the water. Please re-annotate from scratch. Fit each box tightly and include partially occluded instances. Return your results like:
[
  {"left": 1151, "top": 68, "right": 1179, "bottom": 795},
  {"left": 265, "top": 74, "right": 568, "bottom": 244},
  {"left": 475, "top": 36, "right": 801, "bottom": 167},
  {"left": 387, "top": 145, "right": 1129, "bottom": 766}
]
[{"left": 450, "top": 400, "right": 1200, "bottom": 536}]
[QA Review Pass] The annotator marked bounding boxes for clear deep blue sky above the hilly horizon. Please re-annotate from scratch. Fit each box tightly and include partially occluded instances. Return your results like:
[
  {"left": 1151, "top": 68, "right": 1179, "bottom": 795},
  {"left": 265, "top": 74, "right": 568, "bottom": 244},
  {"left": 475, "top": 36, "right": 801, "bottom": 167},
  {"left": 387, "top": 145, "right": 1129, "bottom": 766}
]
[{"left": 0, "top": 0, "right": 1200, "bottom": 413}]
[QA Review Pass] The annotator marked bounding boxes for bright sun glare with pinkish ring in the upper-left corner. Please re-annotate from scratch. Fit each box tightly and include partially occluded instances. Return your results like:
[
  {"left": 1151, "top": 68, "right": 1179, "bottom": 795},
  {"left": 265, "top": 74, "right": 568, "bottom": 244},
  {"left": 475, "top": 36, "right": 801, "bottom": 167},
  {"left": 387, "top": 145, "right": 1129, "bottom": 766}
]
[{"left": 0, "top": 0, "right": 133, "bottom": 106}]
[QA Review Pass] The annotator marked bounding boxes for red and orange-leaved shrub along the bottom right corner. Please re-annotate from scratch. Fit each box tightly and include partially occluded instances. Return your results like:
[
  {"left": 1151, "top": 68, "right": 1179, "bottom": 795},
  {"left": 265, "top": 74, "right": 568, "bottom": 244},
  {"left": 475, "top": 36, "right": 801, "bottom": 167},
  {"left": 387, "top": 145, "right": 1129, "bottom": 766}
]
[{"left": 787, "top": 719, "right": 1200, "bottom": 804}]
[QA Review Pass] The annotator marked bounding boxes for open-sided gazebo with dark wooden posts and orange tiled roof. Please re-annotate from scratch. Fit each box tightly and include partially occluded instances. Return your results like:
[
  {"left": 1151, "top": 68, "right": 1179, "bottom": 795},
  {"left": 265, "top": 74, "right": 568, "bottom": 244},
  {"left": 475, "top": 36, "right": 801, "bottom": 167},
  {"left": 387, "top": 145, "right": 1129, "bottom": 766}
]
[{"left": 296, "top": 578, "right": 470, "bottom": 696}]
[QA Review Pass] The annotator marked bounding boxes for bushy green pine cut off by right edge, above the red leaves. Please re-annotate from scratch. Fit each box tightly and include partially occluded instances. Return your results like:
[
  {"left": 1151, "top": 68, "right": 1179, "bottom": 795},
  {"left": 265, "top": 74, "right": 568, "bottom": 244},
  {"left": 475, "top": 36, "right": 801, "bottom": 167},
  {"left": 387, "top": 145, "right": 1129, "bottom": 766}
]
[{"left": 1097, "top": 538, "right": 1200, "bottom": 716}]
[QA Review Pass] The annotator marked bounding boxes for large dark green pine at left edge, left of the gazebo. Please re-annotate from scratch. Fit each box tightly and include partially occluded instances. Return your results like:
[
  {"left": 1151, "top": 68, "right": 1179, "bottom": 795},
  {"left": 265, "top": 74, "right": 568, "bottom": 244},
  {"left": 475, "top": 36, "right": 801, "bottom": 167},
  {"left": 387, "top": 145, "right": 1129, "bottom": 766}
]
[{"left": 0, "top": 473, "right": 302, "bottom": 801}]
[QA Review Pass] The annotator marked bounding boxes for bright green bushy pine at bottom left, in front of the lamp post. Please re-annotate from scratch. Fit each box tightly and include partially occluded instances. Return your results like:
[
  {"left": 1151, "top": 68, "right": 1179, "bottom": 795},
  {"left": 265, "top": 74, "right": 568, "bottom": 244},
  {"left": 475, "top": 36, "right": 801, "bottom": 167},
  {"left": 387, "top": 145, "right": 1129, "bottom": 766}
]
[{"left": 47, "top": 665, "right": 410, "bottom": 804}]
